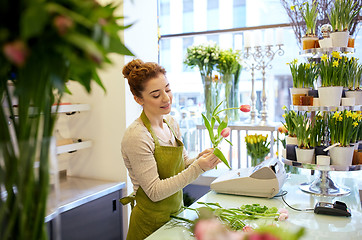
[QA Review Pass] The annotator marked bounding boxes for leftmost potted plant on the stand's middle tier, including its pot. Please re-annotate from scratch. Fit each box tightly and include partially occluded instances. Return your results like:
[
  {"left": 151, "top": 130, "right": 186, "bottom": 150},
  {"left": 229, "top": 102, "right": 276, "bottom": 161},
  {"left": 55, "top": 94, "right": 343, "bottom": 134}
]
[{"left": 287, "top": 59, "right": 318, "bottom": 105}]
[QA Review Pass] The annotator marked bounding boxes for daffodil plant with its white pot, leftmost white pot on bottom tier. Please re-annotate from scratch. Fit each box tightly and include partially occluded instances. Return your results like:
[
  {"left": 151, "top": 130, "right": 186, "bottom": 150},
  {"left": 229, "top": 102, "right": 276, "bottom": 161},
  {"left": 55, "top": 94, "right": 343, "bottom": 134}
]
[{"left": 293, "top": 112, "right": 314, "bottom": 163}]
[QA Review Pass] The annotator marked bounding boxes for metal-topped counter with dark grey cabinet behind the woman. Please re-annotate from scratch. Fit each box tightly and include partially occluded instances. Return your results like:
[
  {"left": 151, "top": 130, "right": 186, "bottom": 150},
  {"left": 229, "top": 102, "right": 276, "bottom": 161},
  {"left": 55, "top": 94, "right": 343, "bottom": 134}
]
[{"left": 45, "top": 176, "right": 126, "bottom": 240}]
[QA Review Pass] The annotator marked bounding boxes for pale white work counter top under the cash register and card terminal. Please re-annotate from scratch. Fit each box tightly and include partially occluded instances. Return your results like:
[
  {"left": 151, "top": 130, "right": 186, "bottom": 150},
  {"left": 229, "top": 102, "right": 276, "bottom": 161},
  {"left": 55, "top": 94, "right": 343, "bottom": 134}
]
[{"left": 147, "top": 174, "right": 362, "bottom": 240}]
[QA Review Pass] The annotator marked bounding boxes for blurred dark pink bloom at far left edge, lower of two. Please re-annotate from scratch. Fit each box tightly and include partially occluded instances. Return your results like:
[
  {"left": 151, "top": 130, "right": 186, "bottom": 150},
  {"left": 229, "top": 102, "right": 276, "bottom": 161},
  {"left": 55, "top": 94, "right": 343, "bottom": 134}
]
[{"left": 3, "top": 40, "right": 28, "bottom": 67}]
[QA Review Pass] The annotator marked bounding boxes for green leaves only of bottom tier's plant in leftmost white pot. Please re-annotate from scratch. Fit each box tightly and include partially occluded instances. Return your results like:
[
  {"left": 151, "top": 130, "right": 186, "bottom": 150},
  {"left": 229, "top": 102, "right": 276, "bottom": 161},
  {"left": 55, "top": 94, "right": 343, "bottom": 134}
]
[{"left": 292, "top": 112, "right": 311, "bottom": 149}]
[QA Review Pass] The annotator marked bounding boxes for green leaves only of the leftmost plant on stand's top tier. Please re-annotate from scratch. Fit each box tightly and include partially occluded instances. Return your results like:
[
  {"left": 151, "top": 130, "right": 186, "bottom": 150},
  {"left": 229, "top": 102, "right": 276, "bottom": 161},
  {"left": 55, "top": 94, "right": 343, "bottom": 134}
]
[{"left": 294, "top": 0, "right": 318, "bottom": 35}]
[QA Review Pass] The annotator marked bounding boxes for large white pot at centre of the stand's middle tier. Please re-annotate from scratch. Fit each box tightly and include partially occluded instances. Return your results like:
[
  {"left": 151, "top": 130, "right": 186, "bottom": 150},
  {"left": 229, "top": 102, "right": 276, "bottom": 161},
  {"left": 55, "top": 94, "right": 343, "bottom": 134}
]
[{"left": 318, "top": 86, "right": 343, "bottom": 107}]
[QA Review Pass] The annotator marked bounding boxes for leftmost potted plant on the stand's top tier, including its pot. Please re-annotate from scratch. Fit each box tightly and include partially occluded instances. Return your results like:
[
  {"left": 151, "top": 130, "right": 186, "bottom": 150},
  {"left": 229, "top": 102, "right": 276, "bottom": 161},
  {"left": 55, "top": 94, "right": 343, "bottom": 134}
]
[{"left": 291, "top": 0, "right": 318, "bottom": 50}]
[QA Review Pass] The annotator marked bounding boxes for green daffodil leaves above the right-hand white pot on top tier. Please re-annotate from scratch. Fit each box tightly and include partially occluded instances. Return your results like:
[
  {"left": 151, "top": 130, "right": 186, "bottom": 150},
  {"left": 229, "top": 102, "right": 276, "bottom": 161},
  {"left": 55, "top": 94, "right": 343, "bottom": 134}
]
[{"left": 328, "top": 0, "right": 361, "bottom": 32}]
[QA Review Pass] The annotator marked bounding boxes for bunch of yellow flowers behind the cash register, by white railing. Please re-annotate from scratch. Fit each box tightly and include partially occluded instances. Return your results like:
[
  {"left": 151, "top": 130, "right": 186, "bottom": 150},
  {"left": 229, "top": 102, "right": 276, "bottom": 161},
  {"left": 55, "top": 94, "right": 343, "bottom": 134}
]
[{"left": 245, "top": 134, "right": 270, "bottom": 166}]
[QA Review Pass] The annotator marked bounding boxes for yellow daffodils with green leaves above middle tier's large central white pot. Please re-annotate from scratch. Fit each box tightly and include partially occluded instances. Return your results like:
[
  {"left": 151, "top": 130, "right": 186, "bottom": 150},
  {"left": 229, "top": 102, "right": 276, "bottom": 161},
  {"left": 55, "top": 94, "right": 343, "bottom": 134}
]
[{"left": 317, "top": 52, "right": 349, "bottom": 87}]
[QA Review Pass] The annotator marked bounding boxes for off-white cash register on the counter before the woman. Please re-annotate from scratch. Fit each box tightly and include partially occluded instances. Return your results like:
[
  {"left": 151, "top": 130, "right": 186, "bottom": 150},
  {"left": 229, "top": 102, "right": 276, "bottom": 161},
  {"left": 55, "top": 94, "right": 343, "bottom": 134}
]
[{"left": 210, "top": 158, "right": 287, "bottom": 198}]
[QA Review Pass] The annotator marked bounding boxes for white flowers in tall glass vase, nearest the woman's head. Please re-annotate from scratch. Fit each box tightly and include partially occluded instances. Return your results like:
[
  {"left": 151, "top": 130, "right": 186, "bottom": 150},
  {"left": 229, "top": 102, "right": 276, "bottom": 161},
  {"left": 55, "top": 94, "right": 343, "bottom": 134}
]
[{"left": 184, "top": 42, "right": 220, "bottom": 118}]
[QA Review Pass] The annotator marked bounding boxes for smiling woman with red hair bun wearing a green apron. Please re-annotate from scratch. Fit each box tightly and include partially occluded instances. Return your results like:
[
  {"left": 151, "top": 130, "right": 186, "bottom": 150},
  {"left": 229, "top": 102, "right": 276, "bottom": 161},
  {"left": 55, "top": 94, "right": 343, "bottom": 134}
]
[{"left": 121, "top": 59, "right": 220, "bottom": 240}]
